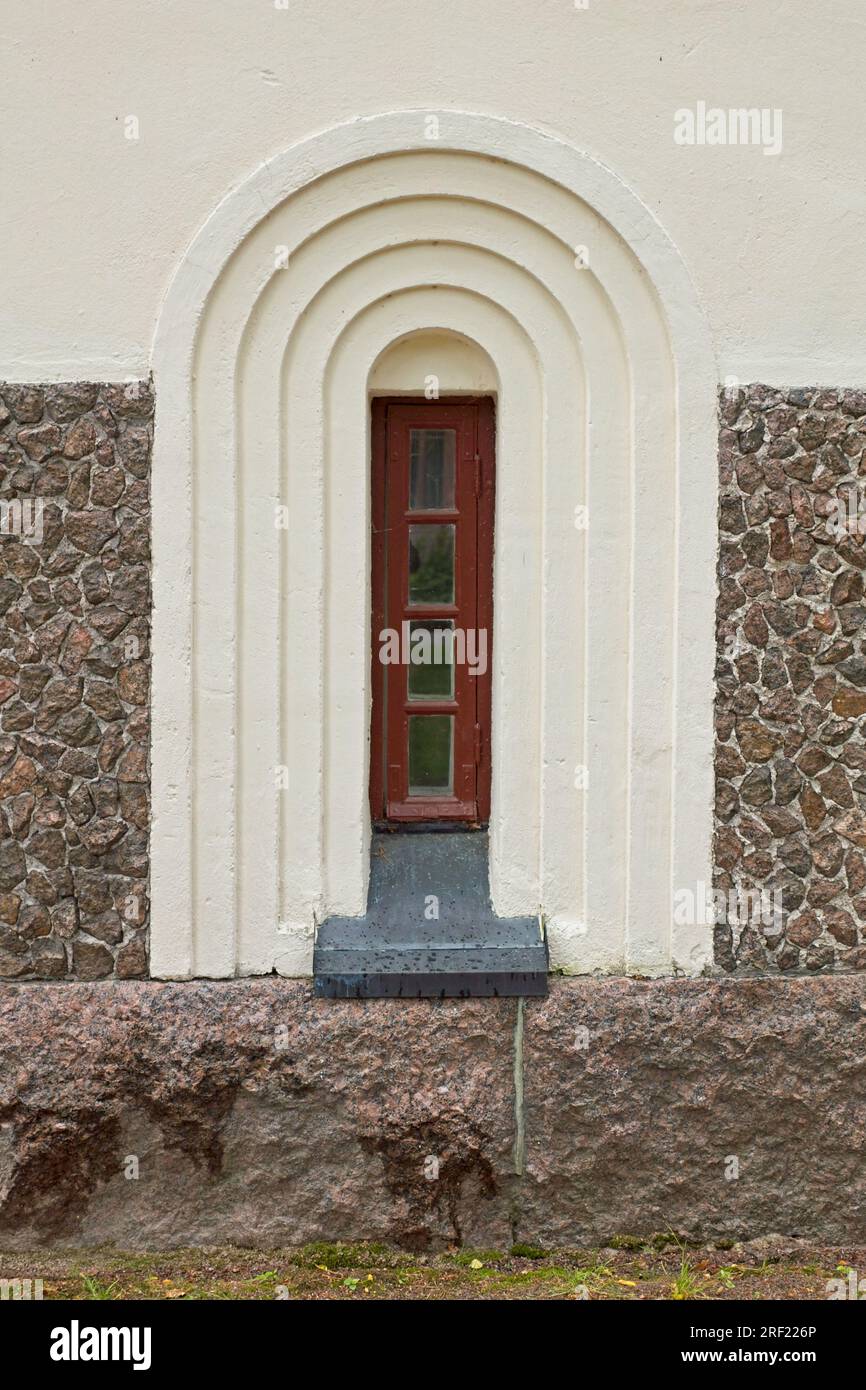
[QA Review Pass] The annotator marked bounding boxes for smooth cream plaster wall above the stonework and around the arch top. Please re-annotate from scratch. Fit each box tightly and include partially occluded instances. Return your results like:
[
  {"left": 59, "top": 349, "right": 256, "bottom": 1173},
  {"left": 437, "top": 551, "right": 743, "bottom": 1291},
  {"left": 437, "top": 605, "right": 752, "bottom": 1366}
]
[{"left": 0, "top": 0, "right": 866, "bottom": 385}]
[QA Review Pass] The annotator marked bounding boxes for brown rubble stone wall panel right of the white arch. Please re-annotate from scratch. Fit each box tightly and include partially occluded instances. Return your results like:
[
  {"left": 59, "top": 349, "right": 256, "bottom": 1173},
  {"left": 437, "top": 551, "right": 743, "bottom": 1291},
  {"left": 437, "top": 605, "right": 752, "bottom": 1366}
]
[{"left": 714, "top": 385, "right": 866, "bottom": 972}]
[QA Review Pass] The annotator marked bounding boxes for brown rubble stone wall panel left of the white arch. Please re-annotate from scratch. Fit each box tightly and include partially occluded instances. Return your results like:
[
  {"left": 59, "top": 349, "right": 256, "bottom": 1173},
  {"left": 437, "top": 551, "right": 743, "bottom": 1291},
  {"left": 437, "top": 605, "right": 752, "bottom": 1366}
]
[{"left": 0, "top": 382, "right": 153, "bottom": 980}]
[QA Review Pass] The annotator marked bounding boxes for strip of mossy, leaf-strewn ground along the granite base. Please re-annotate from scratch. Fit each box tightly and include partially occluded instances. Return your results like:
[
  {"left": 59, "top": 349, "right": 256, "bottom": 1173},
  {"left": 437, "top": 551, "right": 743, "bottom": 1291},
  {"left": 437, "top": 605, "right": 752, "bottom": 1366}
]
[{"left": 0, "top": 1234, "right": 866, "bottom": 1302}]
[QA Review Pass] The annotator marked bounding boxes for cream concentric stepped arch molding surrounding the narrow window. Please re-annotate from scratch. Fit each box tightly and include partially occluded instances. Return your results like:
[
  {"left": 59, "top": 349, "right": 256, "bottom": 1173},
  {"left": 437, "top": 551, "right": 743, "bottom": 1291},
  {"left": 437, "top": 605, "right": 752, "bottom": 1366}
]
[{"left": 152, "top": 111, "right": 717, "bottom": 979}]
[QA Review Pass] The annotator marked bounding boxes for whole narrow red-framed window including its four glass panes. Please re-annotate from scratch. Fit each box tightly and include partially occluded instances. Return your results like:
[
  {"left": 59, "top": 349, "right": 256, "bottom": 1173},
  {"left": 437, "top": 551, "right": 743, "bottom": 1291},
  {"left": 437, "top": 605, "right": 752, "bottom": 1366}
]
[{"left": 370, "top": 398, "right": 495, "bottom": 824}]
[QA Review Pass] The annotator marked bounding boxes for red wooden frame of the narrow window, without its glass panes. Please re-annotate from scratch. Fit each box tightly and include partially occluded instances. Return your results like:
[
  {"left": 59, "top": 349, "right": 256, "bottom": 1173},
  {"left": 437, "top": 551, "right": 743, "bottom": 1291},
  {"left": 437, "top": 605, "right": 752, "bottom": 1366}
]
[{"left": 370, "top": 396, "right": 495, "bottom": 824}]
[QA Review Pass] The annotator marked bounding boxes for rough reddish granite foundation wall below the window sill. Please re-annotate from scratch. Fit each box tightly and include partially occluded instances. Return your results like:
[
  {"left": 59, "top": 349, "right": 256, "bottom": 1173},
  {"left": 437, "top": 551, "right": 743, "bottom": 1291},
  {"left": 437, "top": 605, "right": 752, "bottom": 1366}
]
[{"left": 0, "top": 974, "right": 866, "bottom": 1250}]
